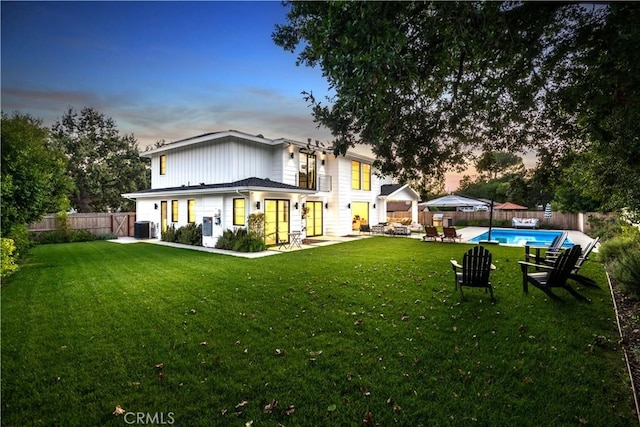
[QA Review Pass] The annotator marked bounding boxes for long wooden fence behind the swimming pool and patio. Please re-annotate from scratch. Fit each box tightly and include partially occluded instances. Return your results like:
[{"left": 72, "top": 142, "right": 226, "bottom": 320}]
[{"left": 388, "top": 210, "right": 616, "bottom": 234}]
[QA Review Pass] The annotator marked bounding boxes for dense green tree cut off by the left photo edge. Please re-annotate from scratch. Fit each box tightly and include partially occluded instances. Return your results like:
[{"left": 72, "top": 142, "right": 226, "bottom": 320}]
[{"left": 1, "top": 112, "right": 73, "bottom": 237}]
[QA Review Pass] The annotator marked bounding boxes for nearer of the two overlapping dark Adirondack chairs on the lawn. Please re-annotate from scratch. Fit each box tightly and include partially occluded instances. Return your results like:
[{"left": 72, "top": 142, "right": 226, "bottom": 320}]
[{"left": 519, "top": 245, "right": 589, "bottom": 302}]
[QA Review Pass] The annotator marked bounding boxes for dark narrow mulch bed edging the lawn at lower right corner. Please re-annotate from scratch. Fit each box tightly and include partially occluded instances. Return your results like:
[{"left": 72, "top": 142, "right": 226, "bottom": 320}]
[{"left": 610, "top": 278, "right": 640, "bottom": 421}]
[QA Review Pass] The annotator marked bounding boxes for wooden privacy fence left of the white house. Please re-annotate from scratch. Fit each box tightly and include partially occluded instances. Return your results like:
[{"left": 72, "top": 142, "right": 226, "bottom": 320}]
[{"left": 29, "top": 212, "right": 136, "bottom": 237}]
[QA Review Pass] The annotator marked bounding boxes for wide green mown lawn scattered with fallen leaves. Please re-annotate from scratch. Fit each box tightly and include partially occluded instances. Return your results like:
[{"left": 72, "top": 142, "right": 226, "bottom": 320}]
[{"left": 1, "top": 237, "right": 637, "bottom": 426}]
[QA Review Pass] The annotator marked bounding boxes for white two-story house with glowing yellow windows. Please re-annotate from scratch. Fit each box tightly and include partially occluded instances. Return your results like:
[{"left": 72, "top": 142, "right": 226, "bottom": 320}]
[{"left": 123, "top": 130, "right": 419, "bottom": 246}]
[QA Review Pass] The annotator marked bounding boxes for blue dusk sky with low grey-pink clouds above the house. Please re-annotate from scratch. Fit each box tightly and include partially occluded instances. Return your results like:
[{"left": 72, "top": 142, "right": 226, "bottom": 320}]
[{"left": 1, "top": 1, "right": 468, "bottom": 190}]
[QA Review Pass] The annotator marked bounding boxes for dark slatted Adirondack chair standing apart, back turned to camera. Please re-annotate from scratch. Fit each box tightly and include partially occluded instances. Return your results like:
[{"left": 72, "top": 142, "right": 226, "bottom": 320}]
[{"left": 451, "top": 246, "right": 496, "bottom": 301}]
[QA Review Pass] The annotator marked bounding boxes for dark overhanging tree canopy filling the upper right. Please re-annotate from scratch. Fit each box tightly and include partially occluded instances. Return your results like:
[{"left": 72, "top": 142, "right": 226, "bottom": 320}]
[{"left": 273, "top": 2, "right": 640, "bottom": 214}]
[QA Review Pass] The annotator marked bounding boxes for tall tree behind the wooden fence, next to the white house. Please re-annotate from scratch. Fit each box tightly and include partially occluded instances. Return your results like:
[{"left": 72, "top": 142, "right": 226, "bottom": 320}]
[{"left": 52, "top": 108, "right": 150, "bottom": 212}]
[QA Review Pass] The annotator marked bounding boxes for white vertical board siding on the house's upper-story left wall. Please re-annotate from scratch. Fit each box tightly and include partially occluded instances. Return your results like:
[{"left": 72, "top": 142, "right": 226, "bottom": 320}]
[{"left": 151, "top": 137, "right": 282, "bottom": 188}]
